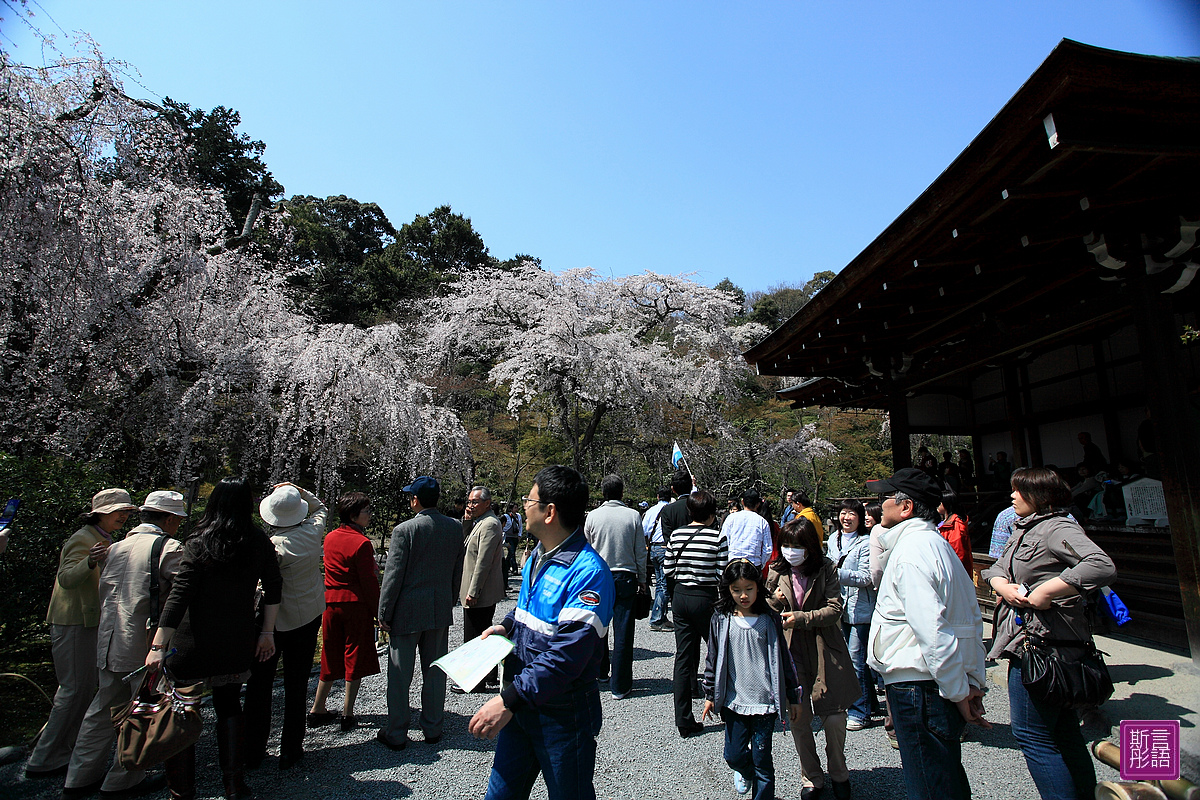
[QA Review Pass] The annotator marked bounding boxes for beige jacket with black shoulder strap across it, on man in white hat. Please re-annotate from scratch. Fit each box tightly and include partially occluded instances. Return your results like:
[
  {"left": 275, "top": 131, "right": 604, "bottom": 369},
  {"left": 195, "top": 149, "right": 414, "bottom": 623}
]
[{"left": 96, "top": 524, "right": 184, "bottom": 673}]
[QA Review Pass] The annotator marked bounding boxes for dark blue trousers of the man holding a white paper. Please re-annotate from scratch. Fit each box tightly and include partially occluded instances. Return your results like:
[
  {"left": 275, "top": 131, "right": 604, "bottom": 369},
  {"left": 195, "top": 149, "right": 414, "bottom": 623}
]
[{"left": 484, "top": 682, "right": 602, "bottom": 800}]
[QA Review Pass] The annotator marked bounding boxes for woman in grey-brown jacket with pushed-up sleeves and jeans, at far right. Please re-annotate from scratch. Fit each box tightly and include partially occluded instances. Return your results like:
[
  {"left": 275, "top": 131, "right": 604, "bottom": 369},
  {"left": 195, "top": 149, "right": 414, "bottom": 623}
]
[{"left": 983, "top": 467, "right": 1116, "bottom": 800}]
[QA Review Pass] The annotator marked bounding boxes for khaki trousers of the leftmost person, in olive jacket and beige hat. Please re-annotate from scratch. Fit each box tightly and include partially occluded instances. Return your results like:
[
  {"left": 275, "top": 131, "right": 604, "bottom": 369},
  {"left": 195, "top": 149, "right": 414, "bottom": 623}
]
[{"left": 25, "top": 625, "right": 98, "bottom": 772}]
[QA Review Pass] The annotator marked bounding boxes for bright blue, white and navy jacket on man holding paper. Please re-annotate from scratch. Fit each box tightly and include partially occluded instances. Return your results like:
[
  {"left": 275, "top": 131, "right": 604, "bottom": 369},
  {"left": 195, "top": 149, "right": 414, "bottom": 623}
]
[{"left": 500, "top": 528, "right": 617, "bottom": 711}]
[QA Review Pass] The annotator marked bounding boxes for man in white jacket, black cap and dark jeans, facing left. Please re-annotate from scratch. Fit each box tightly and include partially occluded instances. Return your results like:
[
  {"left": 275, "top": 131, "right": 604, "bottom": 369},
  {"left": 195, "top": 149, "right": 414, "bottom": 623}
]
[{"left": 866, "top": 469, "right": 990, "bottom": 800}]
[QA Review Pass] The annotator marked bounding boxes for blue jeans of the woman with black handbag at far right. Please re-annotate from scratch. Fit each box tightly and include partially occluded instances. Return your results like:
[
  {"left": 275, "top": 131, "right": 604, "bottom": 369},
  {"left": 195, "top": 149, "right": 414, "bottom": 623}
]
[{"left": 1008, "top": 662, "right": 1096, "bottom": 799}]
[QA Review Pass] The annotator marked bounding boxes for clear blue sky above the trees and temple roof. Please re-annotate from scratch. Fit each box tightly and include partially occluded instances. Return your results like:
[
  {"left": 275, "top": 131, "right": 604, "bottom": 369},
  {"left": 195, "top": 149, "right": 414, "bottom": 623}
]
[{"left": 0, "top": 0, "right": 1200, "bottom": 290}]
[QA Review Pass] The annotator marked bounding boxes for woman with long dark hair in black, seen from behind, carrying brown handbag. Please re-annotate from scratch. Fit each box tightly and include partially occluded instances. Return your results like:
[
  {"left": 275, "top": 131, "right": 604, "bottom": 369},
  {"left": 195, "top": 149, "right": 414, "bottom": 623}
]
[{"left": 146, "top": 477, "right": 283, "bottom": 800}]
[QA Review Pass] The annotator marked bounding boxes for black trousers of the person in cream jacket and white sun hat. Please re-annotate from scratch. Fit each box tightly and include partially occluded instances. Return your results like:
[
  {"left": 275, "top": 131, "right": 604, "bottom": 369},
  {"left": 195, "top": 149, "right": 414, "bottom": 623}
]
[{"left": 246, "top": 616, "right": 320, "bottom": 759}]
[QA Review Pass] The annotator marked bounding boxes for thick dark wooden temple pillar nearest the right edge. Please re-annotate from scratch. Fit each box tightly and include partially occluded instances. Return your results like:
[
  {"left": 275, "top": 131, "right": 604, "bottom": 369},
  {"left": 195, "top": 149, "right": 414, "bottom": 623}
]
[{"left": 1135, "top": 273, "right": 1200, "bottom": 664}]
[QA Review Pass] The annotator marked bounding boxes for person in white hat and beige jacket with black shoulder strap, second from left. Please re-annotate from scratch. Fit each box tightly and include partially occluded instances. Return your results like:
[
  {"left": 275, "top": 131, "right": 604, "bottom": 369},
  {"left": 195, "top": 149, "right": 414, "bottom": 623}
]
[{"left": 62, "top": 492, "right": 187, "bottom": 800}]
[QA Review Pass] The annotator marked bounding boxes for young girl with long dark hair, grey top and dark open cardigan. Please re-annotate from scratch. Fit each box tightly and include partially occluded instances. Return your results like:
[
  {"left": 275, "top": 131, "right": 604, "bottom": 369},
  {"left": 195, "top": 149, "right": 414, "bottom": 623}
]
[{"left": 701, "top": 559, "right": 800, "bottom": 800}]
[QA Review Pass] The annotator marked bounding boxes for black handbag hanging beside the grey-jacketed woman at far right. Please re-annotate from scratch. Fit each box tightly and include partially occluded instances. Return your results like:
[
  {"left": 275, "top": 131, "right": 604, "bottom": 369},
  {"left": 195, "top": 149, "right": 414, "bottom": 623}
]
[{"left": 1021, "top": 626, "right": 1112, "bottom": 709}]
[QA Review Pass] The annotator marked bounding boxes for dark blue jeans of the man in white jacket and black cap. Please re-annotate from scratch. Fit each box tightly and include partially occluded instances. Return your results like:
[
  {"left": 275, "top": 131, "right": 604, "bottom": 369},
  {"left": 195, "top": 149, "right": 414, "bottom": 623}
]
[{"left": 888, "top": 680, "right": 971, "bottom": 800}]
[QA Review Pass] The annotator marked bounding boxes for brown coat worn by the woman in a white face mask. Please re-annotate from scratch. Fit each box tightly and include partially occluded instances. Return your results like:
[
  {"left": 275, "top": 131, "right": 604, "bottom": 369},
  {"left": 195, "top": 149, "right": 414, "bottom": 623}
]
[{"left": 767, "top": 559, "right": 863, "bottom": 717}]
